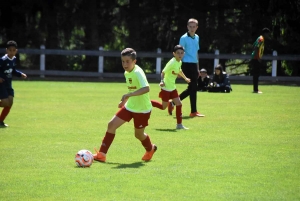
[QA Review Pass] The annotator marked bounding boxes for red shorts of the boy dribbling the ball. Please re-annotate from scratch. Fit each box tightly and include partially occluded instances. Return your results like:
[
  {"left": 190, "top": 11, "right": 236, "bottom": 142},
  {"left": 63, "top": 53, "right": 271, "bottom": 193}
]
[{"left": 116, "top": 106, "right": 151, "bottom": 129}]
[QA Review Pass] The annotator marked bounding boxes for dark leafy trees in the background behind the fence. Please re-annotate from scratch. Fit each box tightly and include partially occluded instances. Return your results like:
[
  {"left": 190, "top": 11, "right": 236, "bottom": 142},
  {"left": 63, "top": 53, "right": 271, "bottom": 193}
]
[{"left": 0, "top": 0, "right": 300, "bottom": 76}]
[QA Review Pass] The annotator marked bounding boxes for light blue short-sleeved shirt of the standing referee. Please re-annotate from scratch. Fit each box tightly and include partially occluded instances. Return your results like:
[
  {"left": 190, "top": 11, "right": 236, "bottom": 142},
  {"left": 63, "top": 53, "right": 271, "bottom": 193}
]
[{"left": 179, "top": 33, "right": 200, "bottom": 63}]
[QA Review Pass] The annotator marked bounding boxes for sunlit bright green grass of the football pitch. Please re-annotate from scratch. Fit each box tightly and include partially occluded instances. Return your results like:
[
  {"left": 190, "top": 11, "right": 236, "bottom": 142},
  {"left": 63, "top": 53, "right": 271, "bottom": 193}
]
[{"left": 0, "top": 81, "right": 300, "bottom": 201}]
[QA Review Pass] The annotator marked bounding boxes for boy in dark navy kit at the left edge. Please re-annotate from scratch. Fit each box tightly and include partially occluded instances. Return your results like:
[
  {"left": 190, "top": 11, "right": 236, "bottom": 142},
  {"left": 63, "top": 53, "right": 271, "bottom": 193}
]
[{"left": 0, "top": 41, "right": 27, "bottom": 128}]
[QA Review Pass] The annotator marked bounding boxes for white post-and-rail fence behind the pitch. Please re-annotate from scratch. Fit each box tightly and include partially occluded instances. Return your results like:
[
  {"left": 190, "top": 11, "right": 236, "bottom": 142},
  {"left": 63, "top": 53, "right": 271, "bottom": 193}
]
[{"left": 0, "top": 45, "right": 300, "bottom": 79}]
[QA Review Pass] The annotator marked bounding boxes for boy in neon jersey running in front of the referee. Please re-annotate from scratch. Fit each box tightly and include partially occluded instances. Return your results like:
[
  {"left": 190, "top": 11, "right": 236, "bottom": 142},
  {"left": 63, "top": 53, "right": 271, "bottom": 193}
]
[{"left": 151, "top": 45, "right": 191, "bottom": 129}]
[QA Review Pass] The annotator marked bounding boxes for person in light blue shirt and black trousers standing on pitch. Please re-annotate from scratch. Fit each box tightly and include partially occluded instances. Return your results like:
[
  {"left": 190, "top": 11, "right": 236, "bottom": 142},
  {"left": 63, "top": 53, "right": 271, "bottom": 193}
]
[{"left": 169, "top": 18, "right": 204, "bottom": 117}]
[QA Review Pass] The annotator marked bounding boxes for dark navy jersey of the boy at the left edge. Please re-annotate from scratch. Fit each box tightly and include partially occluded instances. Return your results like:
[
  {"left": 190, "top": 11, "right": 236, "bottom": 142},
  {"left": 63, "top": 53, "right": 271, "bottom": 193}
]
[{"left": 0, "top": 54, "right": 22, "bottom": 88}]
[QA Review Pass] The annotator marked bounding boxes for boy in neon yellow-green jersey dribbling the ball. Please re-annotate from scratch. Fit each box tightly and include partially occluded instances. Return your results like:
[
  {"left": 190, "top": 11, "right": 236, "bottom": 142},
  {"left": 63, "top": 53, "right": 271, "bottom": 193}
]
[{"left": 94, "top": 48, "right": 157, "bottom": 162}]
